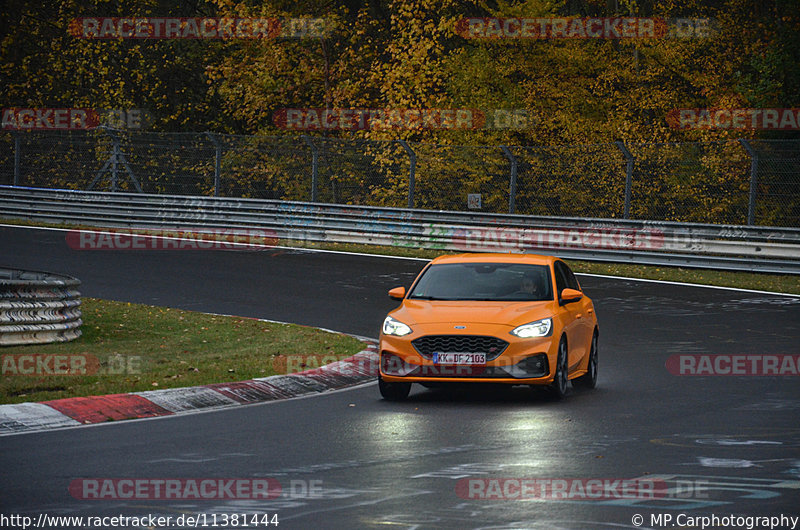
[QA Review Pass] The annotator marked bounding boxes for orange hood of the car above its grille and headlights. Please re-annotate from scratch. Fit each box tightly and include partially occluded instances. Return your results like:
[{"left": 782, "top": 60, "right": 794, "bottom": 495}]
[{"left": 392, "top": 299, "right": 555, "bottom": 327}]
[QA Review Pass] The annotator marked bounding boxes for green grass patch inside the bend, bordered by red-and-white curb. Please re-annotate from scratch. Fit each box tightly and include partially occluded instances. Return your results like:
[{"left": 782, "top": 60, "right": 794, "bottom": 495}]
[{"left": 0, "top": 298, "right": 363, "bottom": 403}]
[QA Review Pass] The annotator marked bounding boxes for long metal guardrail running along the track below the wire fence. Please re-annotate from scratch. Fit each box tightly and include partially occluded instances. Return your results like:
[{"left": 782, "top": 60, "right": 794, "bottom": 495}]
[{"left": 0, "top": 186, "right": 800, "bottom": 274}]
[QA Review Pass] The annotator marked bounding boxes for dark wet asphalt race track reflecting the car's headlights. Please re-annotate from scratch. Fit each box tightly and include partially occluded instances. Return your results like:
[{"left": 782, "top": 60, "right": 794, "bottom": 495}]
[{"left": 0, "top": 224, "right": 800, "bottom": 529}]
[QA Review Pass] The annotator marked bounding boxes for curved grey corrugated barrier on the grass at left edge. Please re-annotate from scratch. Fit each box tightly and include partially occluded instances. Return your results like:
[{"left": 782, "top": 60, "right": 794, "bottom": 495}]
[{"left": 0, "top": 268, "right": 83, "bottom": 346}]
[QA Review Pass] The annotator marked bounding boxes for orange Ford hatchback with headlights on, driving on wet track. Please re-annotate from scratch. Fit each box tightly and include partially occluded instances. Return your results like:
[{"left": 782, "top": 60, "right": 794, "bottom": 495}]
[{"left": 378, "top": 254, "right": 598, "bottom": 400}]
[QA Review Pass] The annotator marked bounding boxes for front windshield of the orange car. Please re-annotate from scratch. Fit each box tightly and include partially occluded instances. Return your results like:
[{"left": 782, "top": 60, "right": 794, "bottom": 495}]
[{"left": 408, "top": 263, "right": 553, "bottom": 302}]
